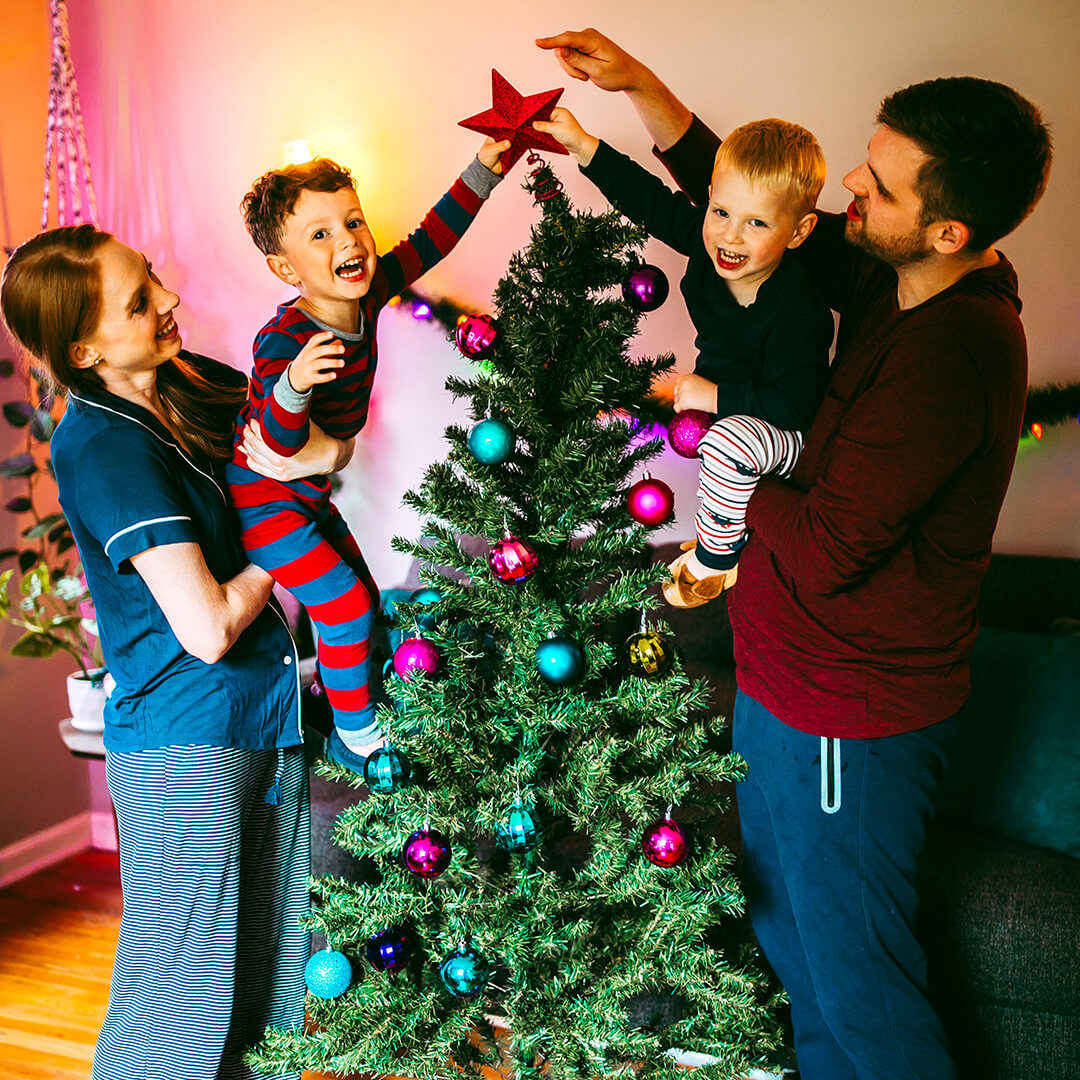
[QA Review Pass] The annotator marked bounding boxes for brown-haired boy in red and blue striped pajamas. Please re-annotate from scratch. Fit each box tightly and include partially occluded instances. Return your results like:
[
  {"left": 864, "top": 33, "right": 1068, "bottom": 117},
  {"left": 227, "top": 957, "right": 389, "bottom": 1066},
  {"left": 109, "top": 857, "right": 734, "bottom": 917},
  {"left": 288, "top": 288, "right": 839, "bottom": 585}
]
[{"left": 227, "top": 139, "right": 510, "bottom": 773}]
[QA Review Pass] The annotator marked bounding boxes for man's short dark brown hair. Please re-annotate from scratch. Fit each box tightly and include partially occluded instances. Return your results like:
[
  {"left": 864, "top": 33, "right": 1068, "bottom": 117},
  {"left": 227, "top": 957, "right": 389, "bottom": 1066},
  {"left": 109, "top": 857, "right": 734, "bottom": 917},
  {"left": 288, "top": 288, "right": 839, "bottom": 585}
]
[{"left": 877, "top": 77, "right": 1053, "bottom": 251}]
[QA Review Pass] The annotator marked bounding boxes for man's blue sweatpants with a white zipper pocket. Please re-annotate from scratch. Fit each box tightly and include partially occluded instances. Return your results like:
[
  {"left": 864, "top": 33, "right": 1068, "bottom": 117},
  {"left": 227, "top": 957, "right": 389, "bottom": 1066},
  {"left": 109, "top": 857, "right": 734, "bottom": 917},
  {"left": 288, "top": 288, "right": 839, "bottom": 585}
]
[{"left": 733, "top": 691, "right": 956, "bottom": 1080}]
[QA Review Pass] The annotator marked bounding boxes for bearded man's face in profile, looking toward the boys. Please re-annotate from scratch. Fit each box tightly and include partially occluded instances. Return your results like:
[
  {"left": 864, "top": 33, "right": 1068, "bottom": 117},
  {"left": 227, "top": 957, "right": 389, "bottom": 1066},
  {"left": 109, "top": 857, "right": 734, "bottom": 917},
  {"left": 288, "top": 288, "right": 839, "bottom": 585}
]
[{"left": 843, "top": 124, "right": 933, "bottom": 268}]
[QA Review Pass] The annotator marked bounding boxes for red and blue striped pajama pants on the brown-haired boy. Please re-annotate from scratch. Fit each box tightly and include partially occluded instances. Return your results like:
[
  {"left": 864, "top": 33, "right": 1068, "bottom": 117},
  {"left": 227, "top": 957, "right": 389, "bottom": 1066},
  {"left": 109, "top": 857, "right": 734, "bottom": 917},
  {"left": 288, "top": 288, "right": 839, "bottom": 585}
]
[{"left": 226, "top": 464, "right": 382, "bottom": 747}]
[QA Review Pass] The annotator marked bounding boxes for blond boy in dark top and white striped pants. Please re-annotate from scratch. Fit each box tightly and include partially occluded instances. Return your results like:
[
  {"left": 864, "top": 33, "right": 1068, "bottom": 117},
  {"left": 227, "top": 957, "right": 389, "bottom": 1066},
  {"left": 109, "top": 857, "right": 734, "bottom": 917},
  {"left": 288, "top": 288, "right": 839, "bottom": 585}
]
[{"left": 536, "top": 108, "right": 833, "bottom": 607}]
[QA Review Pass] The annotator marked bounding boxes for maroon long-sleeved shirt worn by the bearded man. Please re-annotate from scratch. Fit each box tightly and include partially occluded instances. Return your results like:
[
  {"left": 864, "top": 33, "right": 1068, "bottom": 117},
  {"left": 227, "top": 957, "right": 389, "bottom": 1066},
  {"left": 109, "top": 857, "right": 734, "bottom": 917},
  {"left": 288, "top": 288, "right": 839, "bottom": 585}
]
[{"left": 659, "top": 118, "right": 1027, "bottom": 739}]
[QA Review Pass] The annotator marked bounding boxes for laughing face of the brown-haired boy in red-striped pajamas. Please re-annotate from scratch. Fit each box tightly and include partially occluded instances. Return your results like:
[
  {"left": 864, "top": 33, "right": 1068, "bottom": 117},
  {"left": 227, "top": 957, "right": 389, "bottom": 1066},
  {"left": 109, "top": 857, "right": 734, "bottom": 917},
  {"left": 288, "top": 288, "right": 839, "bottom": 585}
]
[{"left": 267, "top": 187, "right": 376, "bottom": 319}]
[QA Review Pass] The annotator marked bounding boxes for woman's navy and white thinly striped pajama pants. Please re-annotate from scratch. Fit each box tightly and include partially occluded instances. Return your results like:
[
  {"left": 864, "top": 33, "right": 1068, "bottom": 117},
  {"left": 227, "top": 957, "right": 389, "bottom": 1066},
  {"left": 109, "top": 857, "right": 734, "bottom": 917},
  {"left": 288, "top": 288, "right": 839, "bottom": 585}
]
[{"left": 93, "top": 746, "right": 311, "bottom": 1080}]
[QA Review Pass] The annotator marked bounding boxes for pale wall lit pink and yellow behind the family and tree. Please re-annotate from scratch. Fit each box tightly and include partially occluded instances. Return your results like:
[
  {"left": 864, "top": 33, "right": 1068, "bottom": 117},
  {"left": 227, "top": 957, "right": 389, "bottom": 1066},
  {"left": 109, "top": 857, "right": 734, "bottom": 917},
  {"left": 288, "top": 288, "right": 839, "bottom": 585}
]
[{"left": 0, "top": 0, "right": 1080, "bottom": 842}]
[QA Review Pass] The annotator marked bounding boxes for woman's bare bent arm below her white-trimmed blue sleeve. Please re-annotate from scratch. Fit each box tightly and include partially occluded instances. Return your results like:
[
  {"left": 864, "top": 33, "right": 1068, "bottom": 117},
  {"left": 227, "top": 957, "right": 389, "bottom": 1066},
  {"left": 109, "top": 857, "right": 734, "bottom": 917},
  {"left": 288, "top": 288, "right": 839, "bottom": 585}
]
[{"left": 131, "top": 543, "right": 273, "bottom": 664}]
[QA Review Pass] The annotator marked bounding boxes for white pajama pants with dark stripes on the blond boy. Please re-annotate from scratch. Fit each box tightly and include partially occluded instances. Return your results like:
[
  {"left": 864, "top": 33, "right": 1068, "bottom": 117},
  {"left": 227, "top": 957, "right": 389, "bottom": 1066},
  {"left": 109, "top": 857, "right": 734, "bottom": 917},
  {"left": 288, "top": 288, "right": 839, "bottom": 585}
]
[{"left": 697, "top": 416, "right": 802, "bottom": 569}]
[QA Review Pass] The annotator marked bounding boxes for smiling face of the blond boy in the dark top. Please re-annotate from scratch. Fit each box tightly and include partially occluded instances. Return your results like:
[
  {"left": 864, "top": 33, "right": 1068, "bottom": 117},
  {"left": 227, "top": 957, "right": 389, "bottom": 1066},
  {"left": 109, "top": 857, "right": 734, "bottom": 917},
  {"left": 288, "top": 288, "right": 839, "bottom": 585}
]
[{"left": 702, "top": 165, "right": 816, "bottom": 305}]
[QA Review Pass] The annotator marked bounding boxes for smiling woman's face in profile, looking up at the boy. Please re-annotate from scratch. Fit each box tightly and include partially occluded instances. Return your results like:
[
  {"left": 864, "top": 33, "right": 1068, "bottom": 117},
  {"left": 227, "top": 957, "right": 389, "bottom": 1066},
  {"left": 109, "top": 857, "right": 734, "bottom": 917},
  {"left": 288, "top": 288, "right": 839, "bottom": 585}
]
[{"left": 78, "top": 239, "right": 181, "bottom": 384}]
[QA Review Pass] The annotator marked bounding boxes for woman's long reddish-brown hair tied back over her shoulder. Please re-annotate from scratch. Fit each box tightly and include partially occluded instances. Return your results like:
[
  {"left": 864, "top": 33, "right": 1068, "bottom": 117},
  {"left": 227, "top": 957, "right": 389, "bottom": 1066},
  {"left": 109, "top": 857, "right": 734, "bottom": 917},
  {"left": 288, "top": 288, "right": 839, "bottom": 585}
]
[{"left": 0, "top": 225, "right": 247, "bottom": 460}]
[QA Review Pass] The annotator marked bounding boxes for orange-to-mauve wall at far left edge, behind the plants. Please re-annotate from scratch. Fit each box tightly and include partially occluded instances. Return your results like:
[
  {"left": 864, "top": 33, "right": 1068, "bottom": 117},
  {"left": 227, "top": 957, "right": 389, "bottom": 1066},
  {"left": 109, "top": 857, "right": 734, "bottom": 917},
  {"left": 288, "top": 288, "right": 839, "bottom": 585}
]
[{"left": 0, "top": 0, "right": 89, "bottom": 848}]
